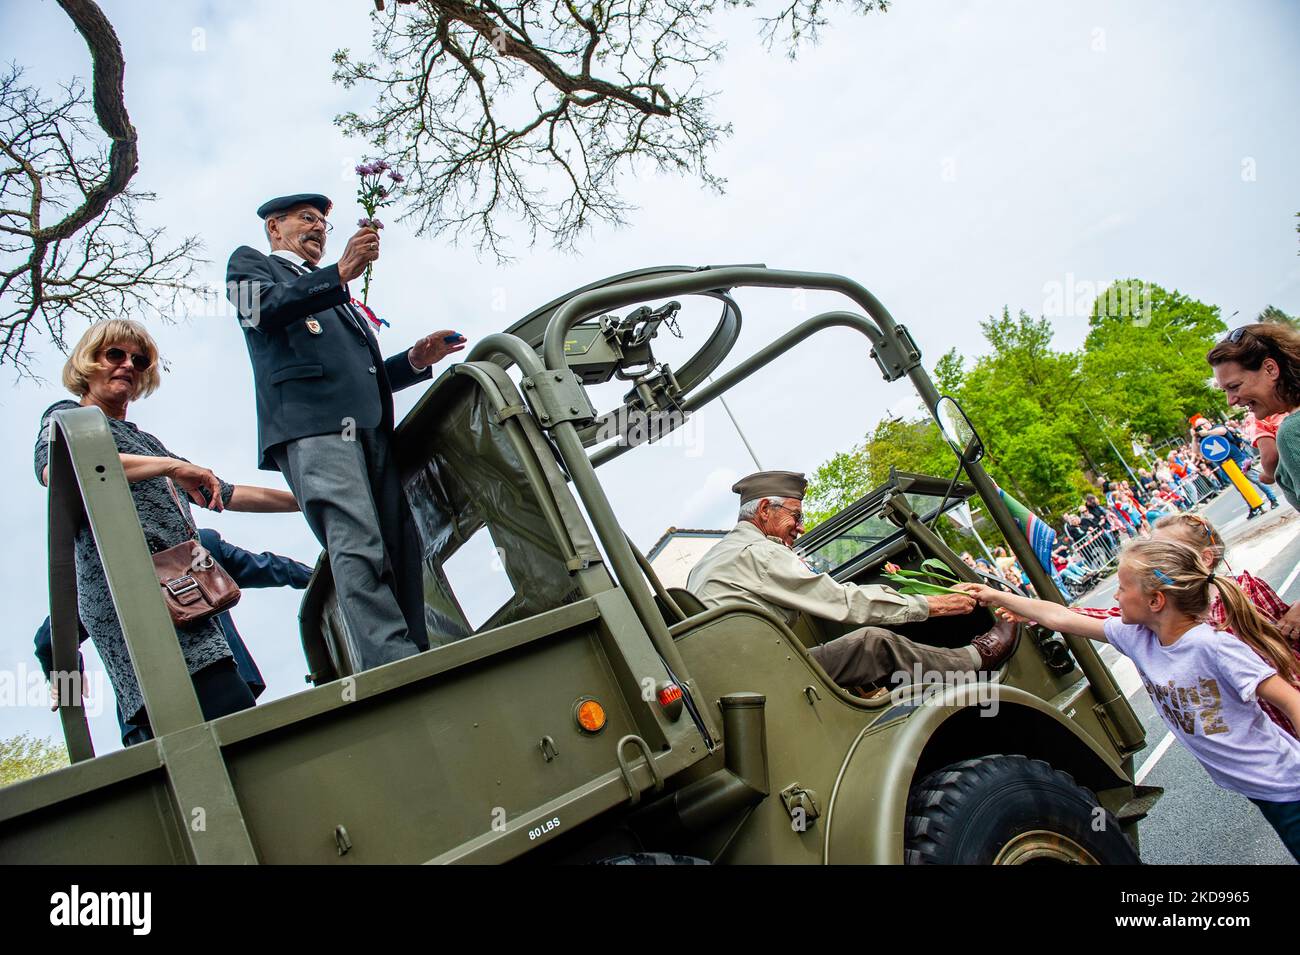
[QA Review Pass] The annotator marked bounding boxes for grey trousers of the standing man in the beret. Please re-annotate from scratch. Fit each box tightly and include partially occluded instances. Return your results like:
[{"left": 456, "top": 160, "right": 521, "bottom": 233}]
[{"left": 270, "top": 429, "right": 429, "bottom": 669}]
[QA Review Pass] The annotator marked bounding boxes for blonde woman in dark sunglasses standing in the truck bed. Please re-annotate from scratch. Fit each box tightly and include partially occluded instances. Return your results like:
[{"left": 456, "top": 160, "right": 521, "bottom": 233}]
[{"left": 35, "top": 320, "right": 298, "bottom": 739}]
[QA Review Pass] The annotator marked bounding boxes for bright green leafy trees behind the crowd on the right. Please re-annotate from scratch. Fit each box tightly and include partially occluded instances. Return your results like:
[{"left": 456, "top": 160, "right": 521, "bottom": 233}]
[{"left": 805, "top": 279, "right": 1226, "bottom": 521}]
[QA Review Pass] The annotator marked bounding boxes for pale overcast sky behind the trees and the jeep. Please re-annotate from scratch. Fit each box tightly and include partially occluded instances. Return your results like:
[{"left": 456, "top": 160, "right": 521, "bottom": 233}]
[{"left": 0, "top": 0, "right": 1300, "bottom": 752}]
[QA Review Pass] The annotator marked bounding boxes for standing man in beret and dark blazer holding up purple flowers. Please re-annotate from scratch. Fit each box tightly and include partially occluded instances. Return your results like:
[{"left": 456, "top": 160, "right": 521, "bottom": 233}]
[{"left": 226, "top": 194, "right": 464, "bottom": 669}]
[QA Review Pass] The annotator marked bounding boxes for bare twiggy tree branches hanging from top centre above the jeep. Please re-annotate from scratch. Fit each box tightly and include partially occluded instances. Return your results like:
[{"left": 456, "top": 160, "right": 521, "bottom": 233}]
[{"left": 334, "top": 0, "right": 888, "bottom": 259}]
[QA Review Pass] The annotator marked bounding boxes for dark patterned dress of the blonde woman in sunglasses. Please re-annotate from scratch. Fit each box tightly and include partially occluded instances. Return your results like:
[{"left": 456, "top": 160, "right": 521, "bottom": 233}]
[{"left": 35, "top": 400, "right": 234, "bottom": 721}]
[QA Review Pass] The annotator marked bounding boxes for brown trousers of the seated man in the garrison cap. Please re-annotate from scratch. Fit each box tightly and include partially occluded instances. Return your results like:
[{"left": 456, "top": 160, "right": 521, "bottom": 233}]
[{"left": 809, "top": 626, "right": 979, "bottom": 687}]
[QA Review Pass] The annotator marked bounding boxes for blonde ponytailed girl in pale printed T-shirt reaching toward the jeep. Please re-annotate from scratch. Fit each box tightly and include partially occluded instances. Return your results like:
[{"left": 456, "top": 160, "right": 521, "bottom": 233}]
[{"left": 958, "top": 539, "right": 1300, "bottom": 861}]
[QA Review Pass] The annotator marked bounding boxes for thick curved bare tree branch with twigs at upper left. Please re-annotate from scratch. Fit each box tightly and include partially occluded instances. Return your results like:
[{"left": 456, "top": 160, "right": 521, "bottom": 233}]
[{"left": 0, "top": 0, "right": 200, "bottom": 373}]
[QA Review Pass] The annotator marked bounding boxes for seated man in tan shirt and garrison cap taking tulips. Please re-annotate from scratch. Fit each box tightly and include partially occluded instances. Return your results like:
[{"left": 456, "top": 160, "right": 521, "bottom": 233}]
[{"left": 686, "top": 470, "right": 1015, "bottom": 686}]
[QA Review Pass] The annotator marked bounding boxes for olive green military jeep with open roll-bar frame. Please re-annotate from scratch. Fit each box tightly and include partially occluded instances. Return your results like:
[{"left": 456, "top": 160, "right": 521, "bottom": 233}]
[{"left": 0, "top": 266, "right": 1158, "bottom": 864}]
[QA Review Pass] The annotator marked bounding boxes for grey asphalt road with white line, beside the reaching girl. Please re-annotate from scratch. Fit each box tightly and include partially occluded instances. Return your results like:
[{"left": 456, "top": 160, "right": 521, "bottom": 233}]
[{"left": 1080, "top": 489, "right": 1300, "bottom": 865}]
